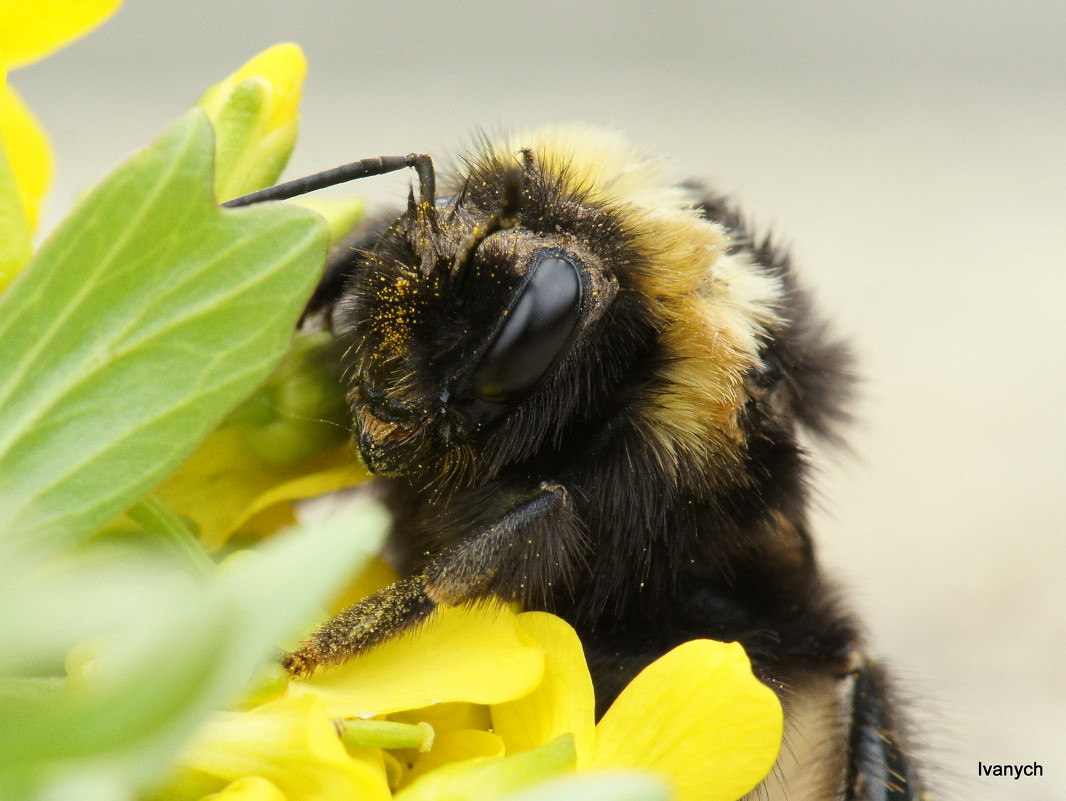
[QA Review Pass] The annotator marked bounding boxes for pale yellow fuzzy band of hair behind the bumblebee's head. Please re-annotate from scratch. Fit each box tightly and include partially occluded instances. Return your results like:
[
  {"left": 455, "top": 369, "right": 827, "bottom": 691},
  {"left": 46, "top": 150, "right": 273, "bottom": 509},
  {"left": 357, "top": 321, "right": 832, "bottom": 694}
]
[{"left": 483, "top": 126, "right": 784, "bottom": 488}]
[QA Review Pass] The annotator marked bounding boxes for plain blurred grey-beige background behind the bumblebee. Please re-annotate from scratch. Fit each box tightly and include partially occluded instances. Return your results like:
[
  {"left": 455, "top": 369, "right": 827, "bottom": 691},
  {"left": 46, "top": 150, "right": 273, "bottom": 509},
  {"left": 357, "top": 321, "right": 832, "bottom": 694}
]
[{"left": 10, "top": 0, "right": 1066, "bottom": 801}]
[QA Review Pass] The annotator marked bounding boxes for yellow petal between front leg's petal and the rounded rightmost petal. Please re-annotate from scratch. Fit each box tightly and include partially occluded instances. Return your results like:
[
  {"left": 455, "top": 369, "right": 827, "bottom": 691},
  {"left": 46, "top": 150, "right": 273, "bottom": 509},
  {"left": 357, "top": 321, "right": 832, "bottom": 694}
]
[{"left": 491, "top": 612, "right": 596, "bottom": 769}]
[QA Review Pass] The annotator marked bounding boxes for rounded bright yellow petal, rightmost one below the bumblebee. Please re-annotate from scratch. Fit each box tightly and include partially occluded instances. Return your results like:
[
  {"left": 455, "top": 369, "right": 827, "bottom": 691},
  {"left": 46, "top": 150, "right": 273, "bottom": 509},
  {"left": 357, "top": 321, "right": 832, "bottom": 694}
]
[{"left": 589, "top": 640, "right": 784, "bottom": 801}]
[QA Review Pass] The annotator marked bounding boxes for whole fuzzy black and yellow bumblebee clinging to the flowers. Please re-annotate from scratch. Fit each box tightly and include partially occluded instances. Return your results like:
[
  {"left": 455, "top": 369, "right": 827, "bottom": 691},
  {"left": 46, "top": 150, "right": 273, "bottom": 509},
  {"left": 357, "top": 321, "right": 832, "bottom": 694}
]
[{"left": 227, "top": 127, "right": 921, "bottom": 800}]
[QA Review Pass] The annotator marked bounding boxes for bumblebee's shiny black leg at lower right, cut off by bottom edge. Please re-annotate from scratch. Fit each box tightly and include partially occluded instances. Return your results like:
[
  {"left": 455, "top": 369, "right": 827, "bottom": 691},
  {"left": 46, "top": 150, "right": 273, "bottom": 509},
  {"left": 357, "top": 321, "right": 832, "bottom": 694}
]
[{"left": 844, "top": 660, "right": 926, "bottom": 801}]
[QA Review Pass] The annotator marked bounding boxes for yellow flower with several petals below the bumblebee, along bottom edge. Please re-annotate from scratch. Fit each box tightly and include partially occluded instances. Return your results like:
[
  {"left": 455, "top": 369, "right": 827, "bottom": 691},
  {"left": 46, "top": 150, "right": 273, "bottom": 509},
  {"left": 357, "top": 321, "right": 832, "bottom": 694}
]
[{"left": 154, "top": 606, "right": 782, "bottom": 801}]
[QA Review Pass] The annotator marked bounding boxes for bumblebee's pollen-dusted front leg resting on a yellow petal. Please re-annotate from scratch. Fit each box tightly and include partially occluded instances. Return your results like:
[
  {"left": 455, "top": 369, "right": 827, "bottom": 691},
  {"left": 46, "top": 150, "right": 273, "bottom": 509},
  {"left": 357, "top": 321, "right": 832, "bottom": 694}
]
[{"left": 282, "top": 482, "right": 584, "bottom": 678}]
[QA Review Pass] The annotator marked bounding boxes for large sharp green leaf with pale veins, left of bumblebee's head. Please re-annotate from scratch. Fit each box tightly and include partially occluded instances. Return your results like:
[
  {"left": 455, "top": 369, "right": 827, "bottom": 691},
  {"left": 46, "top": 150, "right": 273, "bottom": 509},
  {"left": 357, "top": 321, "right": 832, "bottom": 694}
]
[{"left": 0, "top": 111, "right": 327, "bottom": 547}]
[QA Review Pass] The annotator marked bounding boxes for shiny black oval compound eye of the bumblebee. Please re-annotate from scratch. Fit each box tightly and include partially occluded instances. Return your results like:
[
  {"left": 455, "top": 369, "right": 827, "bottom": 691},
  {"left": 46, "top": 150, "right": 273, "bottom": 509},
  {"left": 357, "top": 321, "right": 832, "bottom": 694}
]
[{"left": 471, "top": 254, "right": 581, "bottom": 403}]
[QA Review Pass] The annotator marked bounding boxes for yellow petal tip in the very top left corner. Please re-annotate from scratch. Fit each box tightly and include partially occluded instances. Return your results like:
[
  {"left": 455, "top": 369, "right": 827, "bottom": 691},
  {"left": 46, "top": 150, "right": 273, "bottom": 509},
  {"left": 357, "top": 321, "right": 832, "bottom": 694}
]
[{"left": 0, "top": 0, "right": 122, "bottom": 67}]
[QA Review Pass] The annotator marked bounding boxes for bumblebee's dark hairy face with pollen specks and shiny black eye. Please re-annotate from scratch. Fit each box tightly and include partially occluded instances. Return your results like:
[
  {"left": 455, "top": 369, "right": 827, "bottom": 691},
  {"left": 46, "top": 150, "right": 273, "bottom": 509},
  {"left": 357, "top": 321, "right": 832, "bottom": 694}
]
[{"left": 344, "top": 154, "right": 618, "bottom": 485}]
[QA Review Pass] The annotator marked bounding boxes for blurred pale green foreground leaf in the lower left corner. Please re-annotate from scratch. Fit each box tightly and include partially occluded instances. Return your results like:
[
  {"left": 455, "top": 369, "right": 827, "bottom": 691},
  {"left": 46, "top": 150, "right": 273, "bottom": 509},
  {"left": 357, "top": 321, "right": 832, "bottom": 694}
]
[{"left": 0, "top": 503, "right": 387, "bottom": 799}]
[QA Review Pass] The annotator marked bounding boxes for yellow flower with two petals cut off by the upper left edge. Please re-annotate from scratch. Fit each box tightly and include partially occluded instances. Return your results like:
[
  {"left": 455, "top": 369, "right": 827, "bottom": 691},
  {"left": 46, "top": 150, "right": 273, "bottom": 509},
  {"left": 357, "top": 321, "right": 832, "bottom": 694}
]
[{"left": 0, "top": 0, "right": 120, "bottom": 291}]
